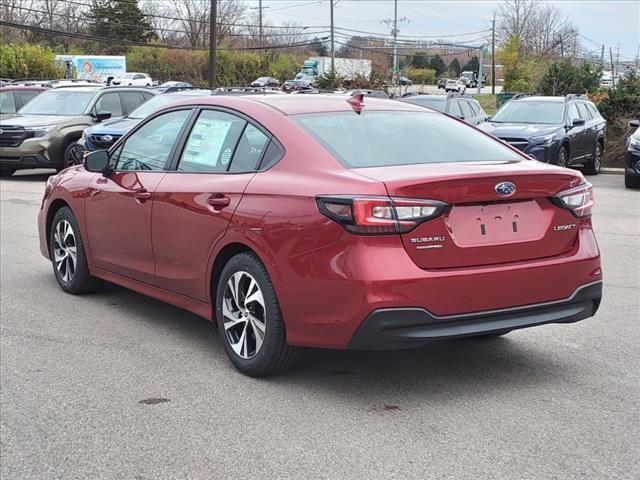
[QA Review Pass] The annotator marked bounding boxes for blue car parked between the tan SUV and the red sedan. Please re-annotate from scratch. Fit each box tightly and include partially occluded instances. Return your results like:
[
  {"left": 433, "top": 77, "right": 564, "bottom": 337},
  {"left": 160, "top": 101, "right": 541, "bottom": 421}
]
[{"left": 78, "top": 90, "right": 213, "bottom": 152}]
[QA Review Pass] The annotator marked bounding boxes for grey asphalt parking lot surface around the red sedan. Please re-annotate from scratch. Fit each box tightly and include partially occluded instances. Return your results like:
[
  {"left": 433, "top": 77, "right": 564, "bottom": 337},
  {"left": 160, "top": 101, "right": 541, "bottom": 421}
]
[{"left": 0, "top": 172, "right": 640, "bottom": 479}]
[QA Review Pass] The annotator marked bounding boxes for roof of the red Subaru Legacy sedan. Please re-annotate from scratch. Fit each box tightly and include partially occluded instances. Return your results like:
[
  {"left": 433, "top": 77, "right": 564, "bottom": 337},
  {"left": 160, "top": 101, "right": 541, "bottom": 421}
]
[{"left": 170, "top": 94, "right": 427, "bottom": 115}]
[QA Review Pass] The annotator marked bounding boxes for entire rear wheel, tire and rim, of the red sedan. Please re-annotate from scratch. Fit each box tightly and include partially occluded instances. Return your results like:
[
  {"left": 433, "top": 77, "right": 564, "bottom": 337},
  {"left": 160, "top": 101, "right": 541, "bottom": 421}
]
[{"left": 216, "top": 253, "right": 300, "bottom": 377}]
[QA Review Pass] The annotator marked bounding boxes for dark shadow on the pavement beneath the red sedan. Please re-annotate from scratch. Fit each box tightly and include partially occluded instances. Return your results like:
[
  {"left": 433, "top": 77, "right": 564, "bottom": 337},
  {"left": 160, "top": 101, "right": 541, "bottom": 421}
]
[{"left": 96, "top": 284, "right": 566, "bottom": 404}]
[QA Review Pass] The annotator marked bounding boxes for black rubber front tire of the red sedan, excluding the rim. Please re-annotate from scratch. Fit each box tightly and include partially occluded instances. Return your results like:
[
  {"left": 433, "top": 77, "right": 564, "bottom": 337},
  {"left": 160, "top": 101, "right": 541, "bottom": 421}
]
[{"left": 49, "top": 207, "right": 101, "bottom": 295}]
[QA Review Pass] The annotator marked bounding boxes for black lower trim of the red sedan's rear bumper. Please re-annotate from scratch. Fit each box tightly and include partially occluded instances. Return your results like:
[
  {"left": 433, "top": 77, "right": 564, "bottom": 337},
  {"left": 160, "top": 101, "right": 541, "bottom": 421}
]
[{"left": 349, "top": 282, "right": 602, "bottom": 350}]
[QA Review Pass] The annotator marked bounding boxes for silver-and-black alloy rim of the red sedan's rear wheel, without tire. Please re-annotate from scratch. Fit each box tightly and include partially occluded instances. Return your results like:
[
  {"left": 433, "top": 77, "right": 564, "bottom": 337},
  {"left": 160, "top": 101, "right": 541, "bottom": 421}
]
[{"left": 222, "top": 271, "right": 267, "bottom": 360}]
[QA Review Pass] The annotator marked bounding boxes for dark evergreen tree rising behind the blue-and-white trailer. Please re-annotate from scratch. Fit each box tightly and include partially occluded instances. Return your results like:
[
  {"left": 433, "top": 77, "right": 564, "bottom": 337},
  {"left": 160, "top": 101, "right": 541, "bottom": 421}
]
[{"left": 89, "top": 0, "right": 157, "bottom": 53}]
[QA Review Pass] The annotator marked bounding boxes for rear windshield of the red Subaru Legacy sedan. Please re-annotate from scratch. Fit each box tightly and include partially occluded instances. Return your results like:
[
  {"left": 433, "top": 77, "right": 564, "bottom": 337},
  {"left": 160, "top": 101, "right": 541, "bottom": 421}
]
[{"left": 289, "top": 111, "right": 522, "bottom": 168}]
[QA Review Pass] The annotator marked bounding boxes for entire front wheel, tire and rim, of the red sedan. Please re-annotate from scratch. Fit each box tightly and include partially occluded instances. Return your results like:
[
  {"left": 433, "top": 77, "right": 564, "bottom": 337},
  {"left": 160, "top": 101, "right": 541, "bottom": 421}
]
[{"left": 49, "top": 207, "right": 100, "bottom": 294}]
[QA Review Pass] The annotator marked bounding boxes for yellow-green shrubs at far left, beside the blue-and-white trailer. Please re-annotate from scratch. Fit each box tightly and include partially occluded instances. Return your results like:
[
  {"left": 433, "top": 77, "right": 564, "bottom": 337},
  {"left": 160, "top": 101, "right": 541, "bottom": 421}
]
[{"left": 0, "top": 43, "right": 64, "bottom": 80}]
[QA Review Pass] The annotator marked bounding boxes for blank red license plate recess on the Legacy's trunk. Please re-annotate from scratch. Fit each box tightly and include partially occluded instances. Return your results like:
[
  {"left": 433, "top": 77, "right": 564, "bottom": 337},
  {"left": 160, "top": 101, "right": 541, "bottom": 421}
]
[{"left": 447, "top": 200, "right": 546, "bottom": 247}]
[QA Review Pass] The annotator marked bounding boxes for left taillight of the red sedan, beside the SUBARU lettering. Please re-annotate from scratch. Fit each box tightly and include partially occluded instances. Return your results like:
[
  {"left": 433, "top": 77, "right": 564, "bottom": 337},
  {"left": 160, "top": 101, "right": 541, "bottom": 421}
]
[{"left": 316, "top": 195, "right": 447, "bottom": 235}]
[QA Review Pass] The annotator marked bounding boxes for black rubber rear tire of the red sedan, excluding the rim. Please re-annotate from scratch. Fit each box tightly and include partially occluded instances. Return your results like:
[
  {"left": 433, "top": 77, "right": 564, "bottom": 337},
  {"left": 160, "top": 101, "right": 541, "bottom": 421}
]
[{"left": 216, "top": 253, "right": 301, "bottom": 377}]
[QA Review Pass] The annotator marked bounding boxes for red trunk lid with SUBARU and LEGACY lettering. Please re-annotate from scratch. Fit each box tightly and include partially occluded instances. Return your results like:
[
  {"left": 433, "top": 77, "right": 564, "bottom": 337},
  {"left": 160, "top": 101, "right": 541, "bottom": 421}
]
[{"left": 354, "top": 160, "right": 583, "bottom": 269}]
